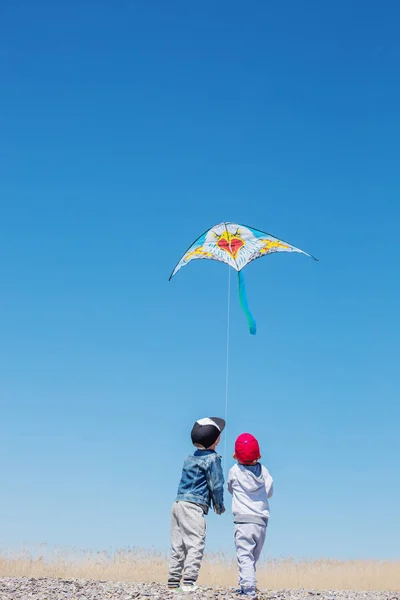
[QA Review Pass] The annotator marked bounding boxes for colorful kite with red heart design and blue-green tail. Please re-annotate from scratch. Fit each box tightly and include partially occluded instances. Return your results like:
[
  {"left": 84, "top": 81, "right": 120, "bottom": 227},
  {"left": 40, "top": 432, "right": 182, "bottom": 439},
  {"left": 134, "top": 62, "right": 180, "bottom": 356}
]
[{"left": 170, "top": 223, "right": 317, "bottom": 335}]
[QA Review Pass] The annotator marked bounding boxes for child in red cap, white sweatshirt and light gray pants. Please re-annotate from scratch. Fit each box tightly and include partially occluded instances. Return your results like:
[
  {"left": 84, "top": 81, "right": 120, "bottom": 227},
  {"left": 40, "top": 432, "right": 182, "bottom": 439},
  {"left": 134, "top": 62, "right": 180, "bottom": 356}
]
[{"left": 228, "top": 433, "right": 273, "bottom": 598}]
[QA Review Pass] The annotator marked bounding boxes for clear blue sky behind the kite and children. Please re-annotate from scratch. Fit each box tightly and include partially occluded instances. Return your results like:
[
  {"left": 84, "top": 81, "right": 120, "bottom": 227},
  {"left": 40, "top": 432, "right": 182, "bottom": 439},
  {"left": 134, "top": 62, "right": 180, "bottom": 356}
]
[{"left": 0, "top": 0, "right": 400, "bottom": 558}]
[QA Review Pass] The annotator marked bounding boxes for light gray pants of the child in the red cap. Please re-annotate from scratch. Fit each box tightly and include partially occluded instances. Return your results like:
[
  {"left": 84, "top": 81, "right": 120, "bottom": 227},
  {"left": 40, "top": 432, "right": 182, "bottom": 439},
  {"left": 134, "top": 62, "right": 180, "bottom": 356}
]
[{"left": 234, "top": 523, "right": 267, "bottom": 590}]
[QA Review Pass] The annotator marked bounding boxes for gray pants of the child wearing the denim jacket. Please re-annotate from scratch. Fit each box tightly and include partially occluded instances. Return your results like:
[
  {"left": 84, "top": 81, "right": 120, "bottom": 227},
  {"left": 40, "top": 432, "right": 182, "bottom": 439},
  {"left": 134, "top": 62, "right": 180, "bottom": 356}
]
[{"left": 168, "top": 501, "right": 206, "bottom": 585}]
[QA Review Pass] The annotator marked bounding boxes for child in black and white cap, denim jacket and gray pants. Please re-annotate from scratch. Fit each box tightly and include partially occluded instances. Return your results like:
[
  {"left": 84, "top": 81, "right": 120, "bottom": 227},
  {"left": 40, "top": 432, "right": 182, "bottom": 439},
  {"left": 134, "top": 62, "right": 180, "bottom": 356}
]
[{"left": 168, "top": 417, "right": 225, "bottom": 592}]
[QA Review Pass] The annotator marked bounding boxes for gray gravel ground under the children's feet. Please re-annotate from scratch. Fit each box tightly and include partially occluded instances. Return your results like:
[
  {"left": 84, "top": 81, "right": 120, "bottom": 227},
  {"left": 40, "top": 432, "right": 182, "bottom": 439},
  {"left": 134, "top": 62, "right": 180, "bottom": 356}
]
[{"left": 0, "top": 577, "right": 400, "bottom": 600}]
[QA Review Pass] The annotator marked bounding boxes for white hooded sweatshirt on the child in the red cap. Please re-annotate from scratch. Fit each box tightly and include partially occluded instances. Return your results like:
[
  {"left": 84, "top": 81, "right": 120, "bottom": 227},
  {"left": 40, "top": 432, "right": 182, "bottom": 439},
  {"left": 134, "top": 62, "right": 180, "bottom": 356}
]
[{"left": 228, "top": 463, "right": 273, "bottom": 525}]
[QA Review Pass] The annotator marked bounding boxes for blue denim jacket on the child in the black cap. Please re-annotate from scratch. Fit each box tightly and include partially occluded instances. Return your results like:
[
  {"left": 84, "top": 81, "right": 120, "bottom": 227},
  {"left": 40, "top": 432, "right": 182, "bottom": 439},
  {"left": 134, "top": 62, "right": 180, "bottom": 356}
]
[{"left": 176, "top": 450, "right": 224, "bottom": 512}]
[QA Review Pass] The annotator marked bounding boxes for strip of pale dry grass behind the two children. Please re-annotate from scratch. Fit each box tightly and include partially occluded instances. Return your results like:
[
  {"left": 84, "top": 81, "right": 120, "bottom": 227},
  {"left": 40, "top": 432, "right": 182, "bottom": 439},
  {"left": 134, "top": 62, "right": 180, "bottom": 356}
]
[{"left": 0, "top": 547, "right": 400, "bottom": 591}]
